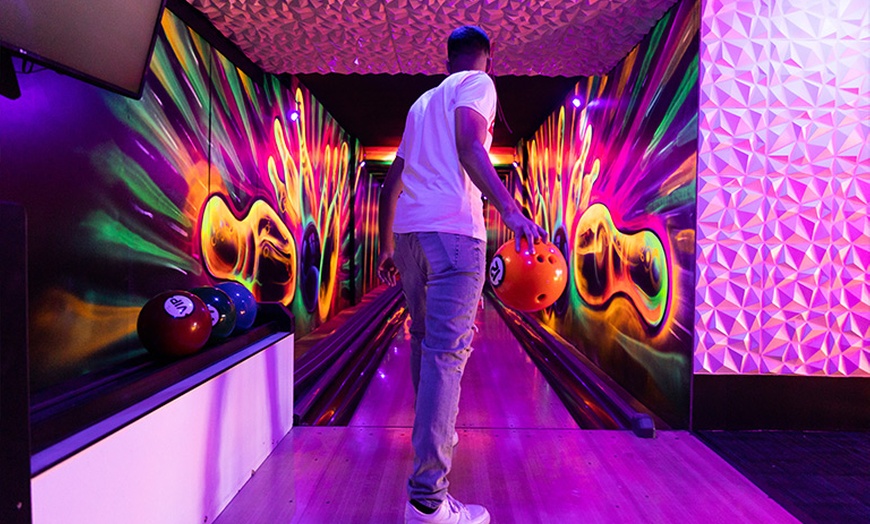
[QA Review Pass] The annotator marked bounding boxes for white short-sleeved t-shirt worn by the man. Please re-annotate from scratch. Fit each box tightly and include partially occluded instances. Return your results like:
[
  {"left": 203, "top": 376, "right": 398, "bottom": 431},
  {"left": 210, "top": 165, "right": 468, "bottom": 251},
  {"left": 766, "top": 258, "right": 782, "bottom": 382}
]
[{"left": 393, "top": 71, "right": 496, "bottom": 241}]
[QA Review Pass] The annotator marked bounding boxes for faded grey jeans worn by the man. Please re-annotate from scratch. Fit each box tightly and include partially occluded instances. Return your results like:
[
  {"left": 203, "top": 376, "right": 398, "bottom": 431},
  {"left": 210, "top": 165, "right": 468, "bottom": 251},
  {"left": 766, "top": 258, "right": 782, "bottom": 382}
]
[{"left": 394, "top": 233, "right": 486, "bottom": 508}]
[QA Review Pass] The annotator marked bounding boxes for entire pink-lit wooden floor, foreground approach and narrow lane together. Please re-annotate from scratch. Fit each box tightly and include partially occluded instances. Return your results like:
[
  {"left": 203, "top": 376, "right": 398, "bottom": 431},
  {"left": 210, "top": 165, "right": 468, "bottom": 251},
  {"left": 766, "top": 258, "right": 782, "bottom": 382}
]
[{"left": 216, "top": 300, "right": 798, "bottom": 524}]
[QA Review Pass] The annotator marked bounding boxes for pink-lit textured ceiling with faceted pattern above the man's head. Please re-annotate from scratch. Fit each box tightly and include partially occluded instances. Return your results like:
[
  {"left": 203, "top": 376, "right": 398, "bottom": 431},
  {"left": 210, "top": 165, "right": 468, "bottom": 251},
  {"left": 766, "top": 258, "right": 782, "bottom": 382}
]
[{"left": 188, "top": 0, "right": 676, "bottom": 76}]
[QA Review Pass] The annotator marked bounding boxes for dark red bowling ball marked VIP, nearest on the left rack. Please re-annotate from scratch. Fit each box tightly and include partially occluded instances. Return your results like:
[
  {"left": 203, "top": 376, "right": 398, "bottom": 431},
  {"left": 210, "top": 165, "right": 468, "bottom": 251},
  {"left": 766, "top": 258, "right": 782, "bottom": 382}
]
[{"left": 136, "top": 290, "right": 211, "bottom": 358}]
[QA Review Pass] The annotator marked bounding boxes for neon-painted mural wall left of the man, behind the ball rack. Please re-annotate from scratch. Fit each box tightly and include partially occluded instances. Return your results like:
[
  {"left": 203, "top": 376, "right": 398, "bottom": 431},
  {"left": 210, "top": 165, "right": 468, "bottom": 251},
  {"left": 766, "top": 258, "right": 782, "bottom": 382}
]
[{"left": 0, "top": 11, "right": 373, "bottom": 390}]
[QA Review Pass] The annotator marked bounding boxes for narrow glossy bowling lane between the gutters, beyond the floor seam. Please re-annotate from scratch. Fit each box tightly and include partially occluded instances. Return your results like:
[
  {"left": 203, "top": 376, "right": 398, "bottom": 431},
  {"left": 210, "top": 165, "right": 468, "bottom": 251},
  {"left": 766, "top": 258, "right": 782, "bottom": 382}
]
[{"left": 350, "top": 294, "right": 578, "bottom": 429}]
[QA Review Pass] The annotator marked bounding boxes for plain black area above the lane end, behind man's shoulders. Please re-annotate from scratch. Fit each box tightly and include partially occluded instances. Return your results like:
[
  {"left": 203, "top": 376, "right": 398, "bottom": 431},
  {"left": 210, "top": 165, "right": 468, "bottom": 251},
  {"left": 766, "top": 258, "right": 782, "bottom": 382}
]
[{"left": 296, "top": 73, "right": 578, "bottom": 147}]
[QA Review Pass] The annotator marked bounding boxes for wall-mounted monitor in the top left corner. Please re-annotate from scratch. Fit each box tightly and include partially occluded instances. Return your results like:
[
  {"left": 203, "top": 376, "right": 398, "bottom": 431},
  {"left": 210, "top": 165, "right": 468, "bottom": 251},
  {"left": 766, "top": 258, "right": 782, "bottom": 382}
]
[{"left": 0, "top": 0, "right": 164, "bottom": 98}]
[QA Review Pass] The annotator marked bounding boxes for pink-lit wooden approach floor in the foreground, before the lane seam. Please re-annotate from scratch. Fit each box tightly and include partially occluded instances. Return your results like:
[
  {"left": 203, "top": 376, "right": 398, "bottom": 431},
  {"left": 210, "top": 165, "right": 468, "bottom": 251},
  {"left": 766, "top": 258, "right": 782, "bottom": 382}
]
[{"left": 216, "top": 427, "right": 798, "bottom": 524}]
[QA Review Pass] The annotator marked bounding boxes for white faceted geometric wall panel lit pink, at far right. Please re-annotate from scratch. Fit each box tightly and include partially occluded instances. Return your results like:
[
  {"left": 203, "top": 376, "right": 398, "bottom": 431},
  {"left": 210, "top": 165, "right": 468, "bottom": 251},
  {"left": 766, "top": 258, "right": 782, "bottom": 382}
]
[{"left": 694, "top": 0, "right": 870, "bottom": 376}]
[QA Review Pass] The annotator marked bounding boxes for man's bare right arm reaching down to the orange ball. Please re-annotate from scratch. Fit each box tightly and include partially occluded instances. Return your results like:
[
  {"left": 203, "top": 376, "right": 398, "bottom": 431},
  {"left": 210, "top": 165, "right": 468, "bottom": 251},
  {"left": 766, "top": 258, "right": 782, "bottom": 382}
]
[{"left": 454, "top": 106, "right": 547, "bottom": 252}]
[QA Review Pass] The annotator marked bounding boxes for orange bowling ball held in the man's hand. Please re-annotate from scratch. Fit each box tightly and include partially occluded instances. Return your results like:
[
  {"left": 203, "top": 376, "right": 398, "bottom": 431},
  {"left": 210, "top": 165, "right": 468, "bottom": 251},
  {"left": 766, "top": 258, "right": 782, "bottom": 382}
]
[{"left": 487, "top": 238, "right": 568, "bottom": 311}]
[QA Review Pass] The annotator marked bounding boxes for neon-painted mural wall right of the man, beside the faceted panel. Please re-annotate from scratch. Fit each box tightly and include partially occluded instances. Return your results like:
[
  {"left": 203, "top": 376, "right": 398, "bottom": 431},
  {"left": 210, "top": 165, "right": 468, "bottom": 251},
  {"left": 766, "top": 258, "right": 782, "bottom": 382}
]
[{"left": 510, "top": 2, "right": 699, "bottom": 426}]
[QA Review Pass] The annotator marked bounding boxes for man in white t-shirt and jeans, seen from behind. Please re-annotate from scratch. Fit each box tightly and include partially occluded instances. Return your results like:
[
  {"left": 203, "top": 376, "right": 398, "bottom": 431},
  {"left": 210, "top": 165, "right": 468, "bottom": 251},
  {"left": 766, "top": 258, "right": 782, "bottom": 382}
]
[{"left": 378, "top": 26, "right": 546, "bottom": 524}]
